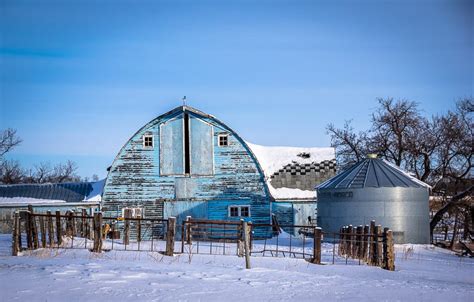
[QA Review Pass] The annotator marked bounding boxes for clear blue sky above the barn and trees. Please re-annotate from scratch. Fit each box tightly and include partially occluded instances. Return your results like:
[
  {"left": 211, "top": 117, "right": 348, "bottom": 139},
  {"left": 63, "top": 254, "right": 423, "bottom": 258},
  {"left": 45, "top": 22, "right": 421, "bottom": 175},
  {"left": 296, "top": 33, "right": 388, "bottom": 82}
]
[{"left": 0, "top": 0, "right": 474, "bottom": 177}]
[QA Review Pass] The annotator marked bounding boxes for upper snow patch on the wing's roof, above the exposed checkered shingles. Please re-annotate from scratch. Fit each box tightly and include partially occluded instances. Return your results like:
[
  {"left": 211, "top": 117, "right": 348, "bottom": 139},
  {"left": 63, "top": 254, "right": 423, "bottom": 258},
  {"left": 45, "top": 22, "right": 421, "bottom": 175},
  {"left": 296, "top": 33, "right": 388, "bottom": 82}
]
[{"left": 246, "top": 142, "right": 336, "bottom": 177}]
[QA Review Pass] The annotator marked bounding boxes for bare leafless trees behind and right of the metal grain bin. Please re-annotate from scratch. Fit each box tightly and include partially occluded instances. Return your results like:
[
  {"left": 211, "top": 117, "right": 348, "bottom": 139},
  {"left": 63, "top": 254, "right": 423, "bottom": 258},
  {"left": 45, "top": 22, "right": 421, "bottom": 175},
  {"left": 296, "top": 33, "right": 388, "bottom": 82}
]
[{"left": 327, "top": 97, "right": 474, "bottom": 243}]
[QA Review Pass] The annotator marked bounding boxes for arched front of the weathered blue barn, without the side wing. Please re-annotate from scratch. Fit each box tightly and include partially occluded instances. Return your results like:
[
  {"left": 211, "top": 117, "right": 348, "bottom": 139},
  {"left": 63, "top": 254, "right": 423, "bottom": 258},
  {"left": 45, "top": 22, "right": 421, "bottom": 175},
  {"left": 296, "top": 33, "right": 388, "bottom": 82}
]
[{"left": 102, "top": 106, "right": 271, "bottom": 236}]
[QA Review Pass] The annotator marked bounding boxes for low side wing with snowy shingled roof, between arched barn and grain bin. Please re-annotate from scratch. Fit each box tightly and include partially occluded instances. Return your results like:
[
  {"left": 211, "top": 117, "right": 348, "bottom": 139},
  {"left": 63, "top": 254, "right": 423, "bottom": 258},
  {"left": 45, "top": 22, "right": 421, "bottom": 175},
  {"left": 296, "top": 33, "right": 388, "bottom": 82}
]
[{"left": 248, "top": 143, "right": 336, "bottom": 234}]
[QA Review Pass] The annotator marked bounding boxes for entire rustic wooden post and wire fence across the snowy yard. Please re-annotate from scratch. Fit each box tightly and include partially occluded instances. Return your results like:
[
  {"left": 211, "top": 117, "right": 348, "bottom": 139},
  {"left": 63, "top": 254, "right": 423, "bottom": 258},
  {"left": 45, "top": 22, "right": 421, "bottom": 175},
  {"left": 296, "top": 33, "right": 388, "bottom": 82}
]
[{"left": 12, "top": 206, "right": 395, "bottom": 270}]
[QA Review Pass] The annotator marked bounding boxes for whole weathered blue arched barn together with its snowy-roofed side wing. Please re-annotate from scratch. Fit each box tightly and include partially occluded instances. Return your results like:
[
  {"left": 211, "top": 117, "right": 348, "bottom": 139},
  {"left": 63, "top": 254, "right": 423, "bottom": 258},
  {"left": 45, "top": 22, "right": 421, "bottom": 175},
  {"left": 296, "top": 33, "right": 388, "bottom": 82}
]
[{"left": 102, "top": 106, "right": 335, "bottom": 236}]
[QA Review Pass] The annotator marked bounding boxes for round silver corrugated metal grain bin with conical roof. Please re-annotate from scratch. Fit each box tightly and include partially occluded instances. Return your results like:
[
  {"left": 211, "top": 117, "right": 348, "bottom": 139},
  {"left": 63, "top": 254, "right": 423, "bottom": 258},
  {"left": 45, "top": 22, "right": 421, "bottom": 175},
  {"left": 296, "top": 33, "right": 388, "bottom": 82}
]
[{"left": 316, "top": 156, "right": 431, "bottom": 243}]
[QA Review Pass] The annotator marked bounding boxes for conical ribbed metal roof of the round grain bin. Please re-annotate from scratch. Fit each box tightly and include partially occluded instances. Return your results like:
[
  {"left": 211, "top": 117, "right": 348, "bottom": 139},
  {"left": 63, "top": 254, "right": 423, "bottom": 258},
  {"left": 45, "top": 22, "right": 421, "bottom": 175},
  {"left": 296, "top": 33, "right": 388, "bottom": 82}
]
[{"left": 316, "top": 157, "right": 430, "bottom": 189}]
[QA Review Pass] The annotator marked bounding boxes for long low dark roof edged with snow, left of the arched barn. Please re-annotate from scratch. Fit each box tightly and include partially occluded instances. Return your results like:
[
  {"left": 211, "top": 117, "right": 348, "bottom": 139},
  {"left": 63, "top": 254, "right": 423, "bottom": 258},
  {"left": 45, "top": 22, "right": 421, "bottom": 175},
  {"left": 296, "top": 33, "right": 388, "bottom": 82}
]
[{"left": 0, "top": 179, "right": 105, "bottom": 204}]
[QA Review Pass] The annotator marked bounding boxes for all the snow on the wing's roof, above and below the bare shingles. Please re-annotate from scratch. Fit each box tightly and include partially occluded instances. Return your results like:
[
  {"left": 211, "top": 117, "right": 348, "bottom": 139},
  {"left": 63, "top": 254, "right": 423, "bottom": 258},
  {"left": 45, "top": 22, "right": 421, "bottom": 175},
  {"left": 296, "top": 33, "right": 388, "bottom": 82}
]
[{"left": 247, "top": 142, "right": 336, "bottom": 199}]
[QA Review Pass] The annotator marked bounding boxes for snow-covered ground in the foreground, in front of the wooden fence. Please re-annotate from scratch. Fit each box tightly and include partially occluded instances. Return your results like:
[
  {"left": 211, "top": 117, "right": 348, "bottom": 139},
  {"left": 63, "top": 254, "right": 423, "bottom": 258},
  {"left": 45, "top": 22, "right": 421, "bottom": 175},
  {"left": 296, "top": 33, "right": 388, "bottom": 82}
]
[{"left": 0, "top": 234, "right": 474, "bottom": 302}]
